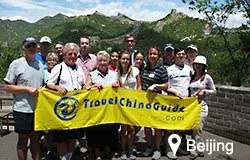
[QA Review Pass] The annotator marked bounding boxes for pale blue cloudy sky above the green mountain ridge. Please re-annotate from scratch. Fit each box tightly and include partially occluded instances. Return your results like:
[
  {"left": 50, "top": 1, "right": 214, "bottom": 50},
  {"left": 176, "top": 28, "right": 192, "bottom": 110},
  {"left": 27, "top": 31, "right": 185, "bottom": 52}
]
[{"left": 0, "top": 0, "right": 246, "bottom": 27}]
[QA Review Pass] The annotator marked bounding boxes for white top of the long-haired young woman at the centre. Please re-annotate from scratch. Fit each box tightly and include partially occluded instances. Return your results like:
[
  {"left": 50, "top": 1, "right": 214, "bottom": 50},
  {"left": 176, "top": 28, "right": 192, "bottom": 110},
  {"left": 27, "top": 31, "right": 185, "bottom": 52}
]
[{"left": 121, "top": 67, "right": 140, "bottom": 89}]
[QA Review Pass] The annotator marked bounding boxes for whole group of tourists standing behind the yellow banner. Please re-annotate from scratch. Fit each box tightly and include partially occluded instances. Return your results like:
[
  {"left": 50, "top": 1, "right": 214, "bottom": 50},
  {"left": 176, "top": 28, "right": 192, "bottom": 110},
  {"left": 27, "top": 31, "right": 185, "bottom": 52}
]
[{"left": 4, "top": 34, "right": 215, "bottom": 160}]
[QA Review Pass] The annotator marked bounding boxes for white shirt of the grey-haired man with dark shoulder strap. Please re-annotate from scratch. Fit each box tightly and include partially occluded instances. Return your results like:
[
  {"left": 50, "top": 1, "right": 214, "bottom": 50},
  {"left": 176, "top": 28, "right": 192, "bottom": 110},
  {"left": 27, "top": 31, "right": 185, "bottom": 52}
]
[{"left": 47, "top": 62, "right": 86, "bottom": 91}]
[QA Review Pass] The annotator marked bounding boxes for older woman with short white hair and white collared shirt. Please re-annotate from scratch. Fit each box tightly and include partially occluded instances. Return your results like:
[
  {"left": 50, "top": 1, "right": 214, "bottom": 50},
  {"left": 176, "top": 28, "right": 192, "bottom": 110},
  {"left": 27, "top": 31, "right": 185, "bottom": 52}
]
[{"left": 86, "top": 51, "right": 119, "bottom": 160}]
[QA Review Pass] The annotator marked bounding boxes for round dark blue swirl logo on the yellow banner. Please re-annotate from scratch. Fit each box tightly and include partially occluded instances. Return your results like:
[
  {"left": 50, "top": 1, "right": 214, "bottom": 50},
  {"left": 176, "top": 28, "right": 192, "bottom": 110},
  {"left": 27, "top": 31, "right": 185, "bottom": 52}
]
[{"left": 54, "top": 97, "right": 79, "bottom": 121}]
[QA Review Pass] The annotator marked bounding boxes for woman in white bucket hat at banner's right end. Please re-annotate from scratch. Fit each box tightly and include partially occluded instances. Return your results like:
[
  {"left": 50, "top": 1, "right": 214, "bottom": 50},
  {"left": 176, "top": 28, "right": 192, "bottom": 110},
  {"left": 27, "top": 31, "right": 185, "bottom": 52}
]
[{"left": 189, "top": 56, "right": 216, "bottom": 159}]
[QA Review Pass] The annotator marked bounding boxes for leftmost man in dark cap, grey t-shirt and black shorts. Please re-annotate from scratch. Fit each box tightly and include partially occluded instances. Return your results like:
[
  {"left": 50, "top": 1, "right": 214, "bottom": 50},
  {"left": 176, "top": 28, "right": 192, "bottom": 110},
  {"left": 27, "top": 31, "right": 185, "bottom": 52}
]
[{"left": 4, "top": 37, "right": 44, "bottom": 160}]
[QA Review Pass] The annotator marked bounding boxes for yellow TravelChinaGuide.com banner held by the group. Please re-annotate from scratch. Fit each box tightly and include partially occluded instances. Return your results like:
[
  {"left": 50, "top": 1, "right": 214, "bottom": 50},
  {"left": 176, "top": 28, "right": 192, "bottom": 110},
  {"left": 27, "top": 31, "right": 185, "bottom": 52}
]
[{"left": 35, "top": 87, "right": 201, "bottom": 130}]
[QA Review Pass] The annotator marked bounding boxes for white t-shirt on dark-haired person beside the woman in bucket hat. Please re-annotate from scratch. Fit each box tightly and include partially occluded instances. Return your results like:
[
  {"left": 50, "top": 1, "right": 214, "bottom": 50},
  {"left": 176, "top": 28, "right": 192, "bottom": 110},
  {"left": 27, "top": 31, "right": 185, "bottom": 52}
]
[{"left": 167, "top": 64, "right": 192, "bottom": 97}]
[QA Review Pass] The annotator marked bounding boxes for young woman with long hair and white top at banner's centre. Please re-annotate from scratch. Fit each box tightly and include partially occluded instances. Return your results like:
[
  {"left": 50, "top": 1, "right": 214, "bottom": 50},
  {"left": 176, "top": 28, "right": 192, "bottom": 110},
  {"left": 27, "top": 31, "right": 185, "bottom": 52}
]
[{"left": 118, "top": 51, "right": 141, "bottom": 160}]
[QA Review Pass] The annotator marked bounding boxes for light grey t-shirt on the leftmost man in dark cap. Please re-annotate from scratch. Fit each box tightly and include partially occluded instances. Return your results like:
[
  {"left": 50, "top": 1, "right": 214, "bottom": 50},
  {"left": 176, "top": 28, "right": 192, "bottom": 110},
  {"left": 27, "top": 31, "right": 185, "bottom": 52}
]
[{"left": 4, "top": 57, "right": 44, "bottom": 113}]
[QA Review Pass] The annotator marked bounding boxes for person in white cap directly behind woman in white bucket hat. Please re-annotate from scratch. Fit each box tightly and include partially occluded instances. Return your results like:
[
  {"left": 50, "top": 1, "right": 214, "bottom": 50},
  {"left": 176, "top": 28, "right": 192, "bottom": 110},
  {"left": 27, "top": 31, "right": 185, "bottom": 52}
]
[{"left": 185, "top": 44, "right": 198, "bottom": 70}]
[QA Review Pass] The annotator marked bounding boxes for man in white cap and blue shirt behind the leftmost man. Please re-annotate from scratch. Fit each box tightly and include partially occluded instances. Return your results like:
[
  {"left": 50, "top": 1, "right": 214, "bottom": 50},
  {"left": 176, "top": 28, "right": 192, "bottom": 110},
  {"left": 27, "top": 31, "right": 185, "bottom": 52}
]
[{"left": 36, "top": 36, "right": 52, "bottom": 69}]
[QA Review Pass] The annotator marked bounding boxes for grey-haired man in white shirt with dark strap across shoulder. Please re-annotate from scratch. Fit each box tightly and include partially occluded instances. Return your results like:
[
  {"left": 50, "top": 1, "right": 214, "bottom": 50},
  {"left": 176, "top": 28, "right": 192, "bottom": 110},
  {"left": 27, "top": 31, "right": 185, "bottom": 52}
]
[{"left": 47, "top": 43, "right": 85, "bottom": 160}]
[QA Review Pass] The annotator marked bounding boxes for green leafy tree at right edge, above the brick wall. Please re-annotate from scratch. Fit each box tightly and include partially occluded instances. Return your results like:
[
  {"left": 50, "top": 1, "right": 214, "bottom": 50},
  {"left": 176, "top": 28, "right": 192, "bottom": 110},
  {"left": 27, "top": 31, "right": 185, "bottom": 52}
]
[{"left": 182, "top": 0, "right": 250, "bottom": 86}]
